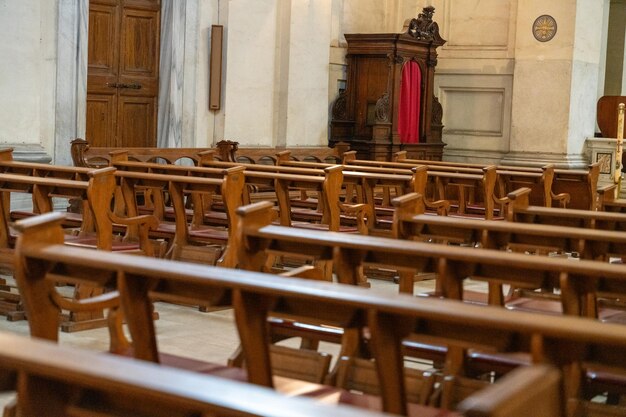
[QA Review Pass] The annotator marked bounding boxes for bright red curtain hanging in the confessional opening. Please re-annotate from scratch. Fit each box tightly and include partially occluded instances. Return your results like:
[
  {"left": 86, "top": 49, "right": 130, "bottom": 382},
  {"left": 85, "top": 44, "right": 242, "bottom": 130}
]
[{"left": 398, "top": 61, "right": 422, "bottom": 143}]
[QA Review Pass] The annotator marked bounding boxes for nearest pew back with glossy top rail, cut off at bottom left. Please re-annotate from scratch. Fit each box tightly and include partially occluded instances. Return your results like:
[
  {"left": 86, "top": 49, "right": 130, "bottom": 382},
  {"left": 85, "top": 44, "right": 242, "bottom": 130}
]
[{"left": 0, "top": 333, "right": 394, "bottom": 417}]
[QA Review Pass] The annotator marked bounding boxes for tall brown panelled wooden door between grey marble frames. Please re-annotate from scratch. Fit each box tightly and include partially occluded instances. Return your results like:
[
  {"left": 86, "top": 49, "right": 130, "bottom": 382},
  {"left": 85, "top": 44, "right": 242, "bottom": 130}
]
[{"left": 86, "top": 0, "right": 161, "bottom": 147}]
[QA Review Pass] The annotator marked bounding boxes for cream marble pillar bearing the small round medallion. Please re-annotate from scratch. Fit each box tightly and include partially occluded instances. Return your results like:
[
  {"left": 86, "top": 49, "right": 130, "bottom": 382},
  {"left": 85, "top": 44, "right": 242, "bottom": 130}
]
[{"left": 502, "top": 0, "right": 604, "bottom": 168}]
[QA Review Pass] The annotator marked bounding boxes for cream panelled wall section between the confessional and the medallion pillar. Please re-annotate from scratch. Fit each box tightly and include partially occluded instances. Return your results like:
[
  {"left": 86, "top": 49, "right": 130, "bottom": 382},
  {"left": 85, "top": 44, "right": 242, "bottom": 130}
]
[{"left": 432, "top": 0, "right": 517, "bottom": 163}]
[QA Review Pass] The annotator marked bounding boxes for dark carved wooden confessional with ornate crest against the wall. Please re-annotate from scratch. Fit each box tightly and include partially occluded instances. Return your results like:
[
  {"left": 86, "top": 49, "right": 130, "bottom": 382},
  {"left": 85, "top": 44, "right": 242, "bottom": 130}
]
[{"left": 329, "top": 7, "right": 446, "bottom": 160}]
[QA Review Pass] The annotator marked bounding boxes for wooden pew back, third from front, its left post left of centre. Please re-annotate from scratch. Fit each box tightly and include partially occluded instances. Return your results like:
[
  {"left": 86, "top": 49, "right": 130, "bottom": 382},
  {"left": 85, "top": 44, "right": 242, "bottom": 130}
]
[{"left": 234, "top": 200, "right": 626, "bottom": 404}]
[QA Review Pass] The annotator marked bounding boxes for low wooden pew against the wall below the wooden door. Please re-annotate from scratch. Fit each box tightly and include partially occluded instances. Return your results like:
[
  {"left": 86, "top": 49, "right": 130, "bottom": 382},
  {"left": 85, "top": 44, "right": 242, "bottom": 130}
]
[{"left": 71, "top": 139, "right": 210, "bottom": 168}]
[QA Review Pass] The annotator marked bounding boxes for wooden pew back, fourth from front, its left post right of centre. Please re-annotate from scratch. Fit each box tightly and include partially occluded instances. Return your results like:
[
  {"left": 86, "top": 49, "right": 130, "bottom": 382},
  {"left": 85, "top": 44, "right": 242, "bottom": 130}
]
[{"left": 393, "top": 194, "right": 626, "bottom": 320}]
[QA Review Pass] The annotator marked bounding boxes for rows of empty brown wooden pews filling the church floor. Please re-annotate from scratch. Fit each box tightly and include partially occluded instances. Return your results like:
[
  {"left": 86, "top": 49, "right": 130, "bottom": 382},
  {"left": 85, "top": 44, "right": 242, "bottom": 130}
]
[{"left": 0, "top": 142, "right": 626, "bottom": 416}]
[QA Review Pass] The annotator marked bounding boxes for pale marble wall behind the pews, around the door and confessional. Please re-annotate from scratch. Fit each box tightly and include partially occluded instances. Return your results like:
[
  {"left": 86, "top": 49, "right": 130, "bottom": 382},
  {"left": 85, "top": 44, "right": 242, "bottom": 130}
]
[{"left": 0, "top": 0, "right": 615, "bottom": 166}]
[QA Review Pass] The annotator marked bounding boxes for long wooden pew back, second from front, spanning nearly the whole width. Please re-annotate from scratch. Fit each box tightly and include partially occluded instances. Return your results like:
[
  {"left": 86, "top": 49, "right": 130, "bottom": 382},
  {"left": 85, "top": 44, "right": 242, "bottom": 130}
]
[{"left": 19, "top": 214, "right": 626, "bottom": 413}]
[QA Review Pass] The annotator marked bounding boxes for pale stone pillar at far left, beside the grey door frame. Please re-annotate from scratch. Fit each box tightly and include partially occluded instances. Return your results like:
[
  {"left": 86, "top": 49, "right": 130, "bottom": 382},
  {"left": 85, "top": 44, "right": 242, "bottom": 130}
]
[{"left": 0, "top": 0, "right": 56, "bottom": 160}]
